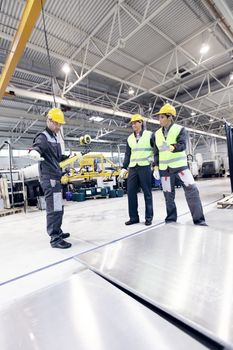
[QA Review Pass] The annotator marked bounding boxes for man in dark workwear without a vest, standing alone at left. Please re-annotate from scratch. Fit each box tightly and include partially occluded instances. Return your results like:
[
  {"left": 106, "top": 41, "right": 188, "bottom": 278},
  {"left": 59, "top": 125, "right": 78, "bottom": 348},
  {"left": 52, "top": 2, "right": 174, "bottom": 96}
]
[{"left": 29, "top": 108, "right": 71, "bottom": 249}]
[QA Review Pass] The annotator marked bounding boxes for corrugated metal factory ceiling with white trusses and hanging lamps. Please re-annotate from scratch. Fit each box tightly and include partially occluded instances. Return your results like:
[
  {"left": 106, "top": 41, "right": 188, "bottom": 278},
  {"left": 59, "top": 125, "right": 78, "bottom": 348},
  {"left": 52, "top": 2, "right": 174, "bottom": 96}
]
[{"left": 0, "top": 0, "right": 233, "bottom": 150}]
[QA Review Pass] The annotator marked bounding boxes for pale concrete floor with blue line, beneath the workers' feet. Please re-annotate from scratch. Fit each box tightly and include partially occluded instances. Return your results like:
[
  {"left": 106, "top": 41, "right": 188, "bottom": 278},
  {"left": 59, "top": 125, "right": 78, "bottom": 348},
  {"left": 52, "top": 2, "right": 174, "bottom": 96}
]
[{"left": 0, "top": 178, "right": 232, "bottom": 307}]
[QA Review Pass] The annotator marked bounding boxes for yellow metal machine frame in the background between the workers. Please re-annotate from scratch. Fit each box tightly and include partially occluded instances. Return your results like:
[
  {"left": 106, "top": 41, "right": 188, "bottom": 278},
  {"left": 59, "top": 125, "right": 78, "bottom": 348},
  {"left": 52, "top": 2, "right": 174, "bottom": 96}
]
[{"left": 60, "top": 152, "right": 120, "bottom": 184}]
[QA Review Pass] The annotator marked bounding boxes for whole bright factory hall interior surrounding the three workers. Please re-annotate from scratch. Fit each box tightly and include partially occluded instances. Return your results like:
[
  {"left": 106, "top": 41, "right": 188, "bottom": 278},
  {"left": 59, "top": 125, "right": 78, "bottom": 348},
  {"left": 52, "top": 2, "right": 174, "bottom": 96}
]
[{"left": 0, "top": 0, "right": 233, "bottom": 350}]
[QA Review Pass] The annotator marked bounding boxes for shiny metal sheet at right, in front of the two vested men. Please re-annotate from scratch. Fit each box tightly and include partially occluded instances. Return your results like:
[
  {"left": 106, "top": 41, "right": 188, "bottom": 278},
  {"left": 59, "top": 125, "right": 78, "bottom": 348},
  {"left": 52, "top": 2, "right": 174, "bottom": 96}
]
[{"left": 78, "top": 223, "right": 233, "bottom": 349}]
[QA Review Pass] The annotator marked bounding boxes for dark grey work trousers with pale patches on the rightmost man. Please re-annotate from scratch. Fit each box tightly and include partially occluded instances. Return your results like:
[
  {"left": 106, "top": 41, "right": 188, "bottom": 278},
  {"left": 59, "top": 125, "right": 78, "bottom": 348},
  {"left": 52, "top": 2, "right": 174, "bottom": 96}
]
[{"left": 161, "top": 169, "right": 205, "bottom": 224}]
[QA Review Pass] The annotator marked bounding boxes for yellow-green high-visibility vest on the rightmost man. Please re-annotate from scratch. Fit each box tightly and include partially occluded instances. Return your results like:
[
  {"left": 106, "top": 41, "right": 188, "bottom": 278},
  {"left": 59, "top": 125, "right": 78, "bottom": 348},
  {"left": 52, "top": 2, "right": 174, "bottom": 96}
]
[{"left": 155, "top": 124, "right": 187, "bottom": 170}]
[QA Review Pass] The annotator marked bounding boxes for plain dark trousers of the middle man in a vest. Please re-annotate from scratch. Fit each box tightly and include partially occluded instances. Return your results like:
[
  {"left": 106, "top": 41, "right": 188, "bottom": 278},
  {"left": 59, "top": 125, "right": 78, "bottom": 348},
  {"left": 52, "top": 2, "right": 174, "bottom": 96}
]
[{"left": 127, "top": 165, "right": 153, "bottom": 221}]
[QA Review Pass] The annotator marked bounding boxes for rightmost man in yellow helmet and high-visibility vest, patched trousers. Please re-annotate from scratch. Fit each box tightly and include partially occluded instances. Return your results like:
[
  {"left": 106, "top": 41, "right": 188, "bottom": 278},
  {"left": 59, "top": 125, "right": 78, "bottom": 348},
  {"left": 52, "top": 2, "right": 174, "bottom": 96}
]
[{"left": 153, "top": 103, "right": 207, "bottom": 226}]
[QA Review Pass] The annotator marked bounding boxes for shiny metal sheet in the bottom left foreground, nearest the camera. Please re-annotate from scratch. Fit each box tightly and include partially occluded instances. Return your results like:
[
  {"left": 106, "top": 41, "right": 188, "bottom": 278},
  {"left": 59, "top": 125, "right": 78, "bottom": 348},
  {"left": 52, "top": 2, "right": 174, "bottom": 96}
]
[{"left": 0, "top": 271, "right": 207, "bottom": 350}]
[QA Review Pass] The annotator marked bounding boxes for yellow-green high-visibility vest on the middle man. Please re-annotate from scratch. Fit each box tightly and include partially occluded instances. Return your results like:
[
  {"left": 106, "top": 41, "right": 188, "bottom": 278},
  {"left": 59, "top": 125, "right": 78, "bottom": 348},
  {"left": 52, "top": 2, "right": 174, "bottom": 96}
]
[{"left": 128, "top": 130, "right": 153, "bottom": 168}]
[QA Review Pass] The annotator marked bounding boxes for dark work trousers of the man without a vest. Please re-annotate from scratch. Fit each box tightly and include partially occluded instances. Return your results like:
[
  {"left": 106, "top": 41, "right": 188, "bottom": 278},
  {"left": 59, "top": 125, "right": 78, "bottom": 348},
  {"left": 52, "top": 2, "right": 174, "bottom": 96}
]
[{"left": 40, "top": 176, "right": 63, "bottom": 243}]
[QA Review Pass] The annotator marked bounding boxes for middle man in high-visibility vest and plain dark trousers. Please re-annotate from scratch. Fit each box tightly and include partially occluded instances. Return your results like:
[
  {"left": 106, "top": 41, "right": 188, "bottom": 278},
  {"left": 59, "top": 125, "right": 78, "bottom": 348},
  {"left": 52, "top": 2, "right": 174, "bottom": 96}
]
[{"left": 119, "top": 114, "right": 154, "bottom": 226}]
